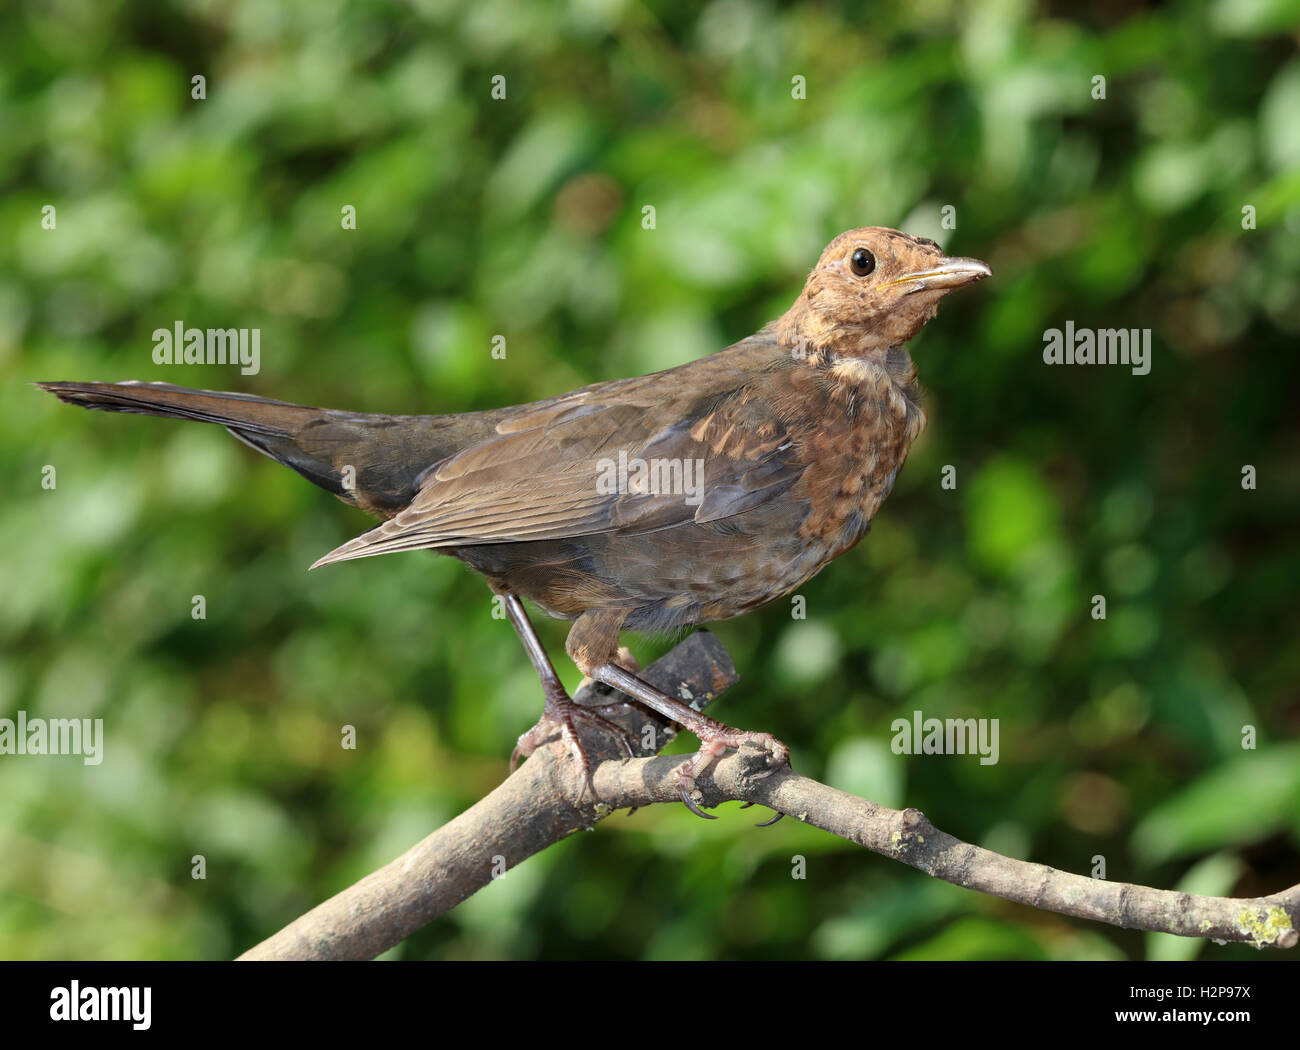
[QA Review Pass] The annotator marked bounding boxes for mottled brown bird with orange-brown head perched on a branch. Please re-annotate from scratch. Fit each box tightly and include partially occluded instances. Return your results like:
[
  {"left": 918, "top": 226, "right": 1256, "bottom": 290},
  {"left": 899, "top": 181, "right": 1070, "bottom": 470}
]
[{"left": 40, "top": 226, "right": 992, "bottom": 816}]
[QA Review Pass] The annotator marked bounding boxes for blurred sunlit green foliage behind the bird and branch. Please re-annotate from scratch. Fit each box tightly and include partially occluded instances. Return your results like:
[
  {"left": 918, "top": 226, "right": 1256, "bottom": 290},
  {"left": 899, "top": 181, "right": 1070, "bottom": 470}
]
[{"left": 0, "top": 0, "right": 1300, "bottom": 959}]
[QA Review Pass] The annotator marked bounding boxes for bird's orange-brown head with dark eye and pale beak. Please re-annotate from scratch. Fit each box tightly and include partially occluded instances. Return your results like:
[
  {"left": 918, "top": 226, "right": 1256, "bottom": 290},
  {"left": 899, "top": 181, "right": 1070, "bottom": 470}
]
[{"left": 777, "top": 226, "right": 993, "bottom": 355}]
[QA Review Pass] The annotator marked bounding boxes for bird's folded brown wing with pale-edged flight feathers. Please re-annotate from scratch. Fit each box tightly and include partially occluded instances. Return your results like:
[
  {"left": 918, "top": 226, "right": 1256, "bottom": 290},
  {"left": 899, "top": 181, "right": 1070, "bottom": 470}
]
[{"left": 313, "top": 348, "right": 805, "bottom": 568}]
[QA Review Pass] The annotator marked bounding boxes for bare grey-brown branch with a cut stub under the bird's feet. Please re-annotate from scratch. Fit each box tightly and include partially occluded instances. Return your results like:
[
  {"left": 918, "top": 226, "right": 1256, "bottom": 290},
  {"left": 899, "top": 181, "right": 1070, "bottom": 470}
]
[{"left": 239, "top": 632, "right": 1300, "bottom": 960}]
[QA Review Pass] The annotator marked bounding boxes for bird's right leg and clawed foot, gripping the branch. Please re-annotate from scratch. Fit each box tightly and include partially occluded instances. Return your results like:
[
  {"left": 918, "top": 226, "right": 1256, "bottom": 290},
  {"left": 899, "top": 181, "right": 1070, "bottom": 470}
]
[{"left": 566, "top": 612, "right": 790, "bottom": 826}]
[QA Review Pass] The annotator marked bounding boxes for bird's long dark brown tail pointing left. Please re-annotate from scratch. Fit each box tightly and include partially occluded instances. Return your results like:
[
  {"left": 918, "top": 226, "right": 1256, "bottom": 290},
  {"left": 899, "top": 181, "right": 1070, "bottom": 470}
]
[{"left": 38, "top": 382, "right": 473, "bottom": 517}]
